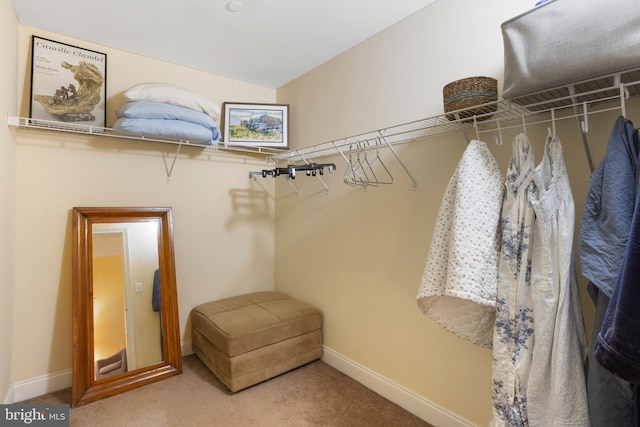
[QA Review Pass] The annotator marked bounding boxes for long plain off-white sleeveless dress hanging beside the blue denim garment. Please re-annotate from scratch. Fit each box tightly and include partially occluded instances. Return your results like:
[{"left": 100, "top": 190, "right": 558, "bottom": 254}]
[{"left": 527, "top": 135, "right": 589, "bottom": 427}]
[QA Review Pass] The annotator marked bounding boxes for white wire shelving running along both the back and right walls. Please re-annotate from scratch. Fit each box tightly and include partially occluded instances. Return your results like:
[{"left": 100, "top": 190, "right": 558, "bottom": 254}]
[{"left": 8, "top": 69, "right": 640, "bottom": 169}]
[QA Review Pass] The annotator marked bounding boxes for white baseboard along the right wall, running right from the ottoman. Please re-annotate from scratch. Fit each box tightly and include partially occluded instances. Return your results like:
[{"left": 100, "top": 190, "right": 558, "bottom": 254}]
[{"left": 322, "top": 346, "right": 474, "bottom": 427}]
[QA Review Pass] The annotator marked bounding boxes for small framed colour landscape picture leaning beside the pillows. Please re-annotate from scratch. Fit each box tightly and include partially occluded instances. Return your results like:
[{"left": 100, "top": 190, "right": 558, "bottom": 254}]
[{"left": 222, "top": 102, "right": 289, "bottom": 148}]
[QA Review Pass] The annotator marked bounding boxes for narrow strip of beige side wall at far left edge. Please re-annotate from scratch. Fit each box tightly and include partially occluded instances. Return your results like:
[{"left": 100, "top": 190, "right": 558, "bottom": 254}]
[{"left": 0, "top": 0, "right": 18, "bottom": 403}]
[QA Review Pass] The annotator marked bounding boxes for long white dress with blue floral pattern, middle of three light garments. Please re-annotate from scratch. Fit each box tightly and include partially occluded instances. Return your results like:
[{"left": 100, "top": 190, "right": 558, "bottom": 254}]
[{"left": 490, "top": 134, "right": 537, "bottom": 427}]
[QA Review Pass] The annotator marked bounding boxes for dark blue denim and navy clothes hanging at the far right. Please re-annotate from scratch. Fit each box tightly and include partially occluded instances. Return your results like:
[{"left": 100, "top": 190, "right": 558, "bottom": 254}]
[{"left": 578, "top": 116, "right": 640, "bottom": 427}]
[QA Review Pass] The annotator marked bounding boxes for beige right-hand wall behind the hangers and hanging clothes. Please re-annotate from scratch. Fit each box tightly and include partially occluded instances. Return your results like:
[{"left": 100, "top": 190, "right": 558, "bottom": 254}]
[{"left": 275, "top": 0, "right": 637, "bottom": 425}]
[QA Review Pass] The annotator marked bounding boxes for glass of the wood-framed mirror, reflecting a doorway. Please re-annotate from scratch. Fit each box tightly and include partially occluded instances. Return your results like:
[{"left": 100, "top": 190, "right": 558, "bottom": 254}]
[{"left": 93, "top": 221, "right": 163, "bottom": 379}]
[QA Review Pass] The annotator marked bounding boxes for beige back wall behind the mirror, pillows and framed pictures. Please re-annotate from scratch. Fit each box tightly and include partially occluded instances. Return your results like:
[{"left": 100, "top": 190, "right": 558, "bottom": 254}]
[{"left": 8, "top": 23, "right": 275, "bottom": 382}]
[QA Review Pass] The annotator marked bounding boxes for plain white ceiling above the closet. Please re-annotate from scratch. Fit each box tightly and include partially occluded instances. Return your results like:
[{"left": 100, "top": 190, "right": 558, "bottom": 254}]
[{"left": 13, "top": 0, "right": 435, "bottom": 88}]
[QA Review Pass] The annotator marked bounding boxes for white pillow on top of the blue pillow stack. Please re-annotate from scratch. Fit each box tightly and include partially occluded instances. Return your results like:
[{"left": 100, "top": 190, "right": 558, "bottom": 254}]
[{"left": 124, "top": 83, "right": 220, "bottom": 120}]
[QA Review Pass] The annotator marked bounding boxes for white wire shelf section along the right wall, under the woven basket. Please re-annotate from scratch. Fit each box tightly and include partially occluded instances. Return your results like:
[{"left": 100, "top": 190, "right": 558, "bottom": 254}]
[{"left": 269, "top": 69, "right": 640, "bottom": 162}]
